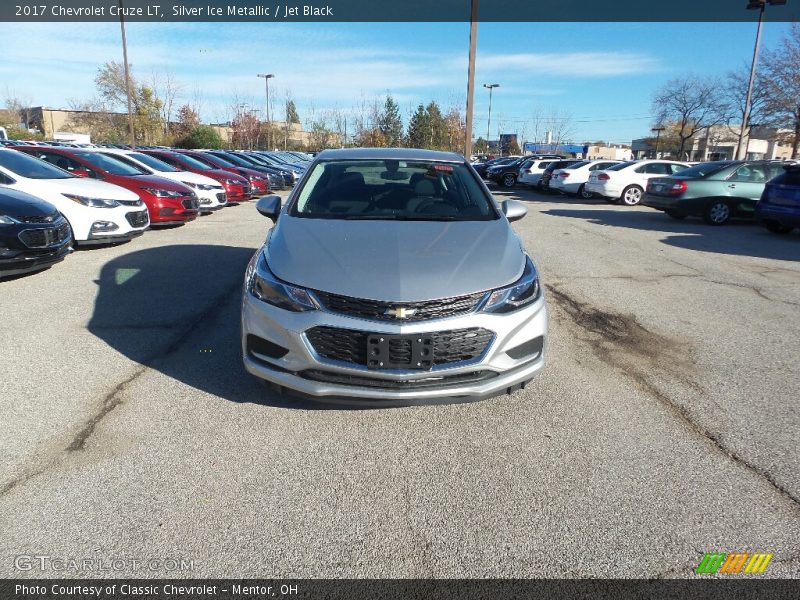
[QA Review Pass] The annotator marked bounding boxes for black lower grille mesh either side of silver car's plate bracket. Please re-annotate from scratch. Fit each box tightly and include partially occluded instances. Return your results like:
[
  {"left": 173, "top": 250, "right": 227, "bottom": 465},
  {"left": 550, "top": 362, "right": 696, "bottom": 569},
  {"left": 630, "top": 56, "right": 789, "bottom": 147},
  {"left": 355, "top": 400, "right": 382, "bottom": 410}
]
[{"left": 306, "top": 327, "right": 494, "bottom": 366}]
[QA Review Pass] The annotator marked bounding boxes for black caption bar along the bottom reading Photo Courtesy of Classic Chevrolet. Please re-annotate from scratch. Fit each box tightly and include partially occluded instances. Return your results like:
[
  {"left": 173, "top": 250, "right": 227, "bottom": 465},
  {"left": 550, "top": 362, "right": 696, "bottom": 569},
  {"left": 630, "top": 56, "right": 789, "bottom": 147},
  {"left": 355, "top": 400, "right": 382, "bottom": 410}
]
[{"left": 0, "top": 577, "right": 800, "bottom": 600}]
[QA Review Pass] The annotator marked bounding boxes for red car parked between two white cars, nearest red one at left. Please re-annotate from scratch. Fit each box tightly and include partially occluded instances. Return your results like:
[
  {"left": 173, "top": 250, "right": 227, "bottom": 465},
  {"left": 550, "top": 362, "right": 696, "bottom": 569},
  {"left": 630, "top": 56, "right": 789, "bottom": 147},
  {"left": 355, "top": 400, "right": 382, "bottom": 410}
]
[{"left": 15, "top": 146, "right": 200, "bottom": 226}]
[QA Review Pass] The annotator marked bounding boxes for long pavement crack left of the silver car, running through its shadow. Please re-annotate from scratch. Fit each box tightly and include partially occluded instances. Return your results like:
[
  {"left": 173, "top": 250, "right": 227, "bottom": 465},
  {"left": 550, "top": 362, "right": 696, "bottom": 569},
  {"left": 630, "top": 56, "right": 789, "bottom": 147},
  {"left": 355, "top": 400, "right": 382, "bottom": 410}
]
[{"left": 0, "top": 279, "right": 241, "bottom": 498}]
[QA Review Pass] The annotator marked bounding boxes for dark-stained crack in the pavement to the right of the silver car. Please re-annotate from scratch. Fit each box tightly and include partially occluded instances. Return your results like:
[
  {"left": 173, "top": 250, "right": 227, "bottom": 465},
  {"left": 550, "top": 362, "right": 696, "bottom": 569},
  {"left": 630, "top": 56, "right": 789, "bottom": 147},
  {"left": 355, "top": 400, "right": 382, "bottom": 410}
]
[{"left": 547, "top": 284, "right": 800, "bottom": 509}]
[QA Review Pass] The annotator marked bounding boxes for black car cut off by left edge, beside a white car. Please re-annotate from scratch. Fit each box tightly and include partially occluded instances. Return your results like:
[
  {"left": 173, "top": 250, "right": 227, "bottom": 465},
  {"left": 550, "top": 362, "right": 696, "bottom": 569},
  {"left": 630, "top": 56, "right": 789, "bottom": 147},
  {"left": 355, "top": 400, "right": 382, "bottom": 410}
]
[{"left": 0, "top": 188, "right": 72, "bottom": 279}]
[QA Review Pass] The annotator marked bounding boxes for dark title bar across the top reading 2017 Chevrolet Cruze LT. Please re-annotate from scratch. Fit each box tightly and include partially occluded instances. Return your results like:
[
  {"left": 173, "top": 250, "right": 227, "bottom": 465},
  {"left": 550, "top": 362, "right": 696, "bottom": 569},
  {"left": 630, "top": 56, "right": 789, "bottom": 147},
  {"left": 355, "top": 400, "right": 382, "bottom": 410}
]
[{"left": 0, "top": 0, "right": 800, "bottom": 23}]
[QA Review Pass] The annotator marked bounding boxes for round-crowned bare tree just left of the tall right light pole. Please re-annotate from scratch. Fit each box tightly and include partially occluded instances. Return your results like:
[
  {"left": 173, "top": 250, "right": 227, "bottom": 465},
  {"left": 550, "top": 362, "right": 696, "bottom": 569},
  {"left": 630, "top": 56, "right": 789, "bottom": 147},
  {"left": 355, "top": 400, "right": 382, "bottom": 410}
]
[{"left": 653, "top": 75, "right": 728, "bottom": 159}]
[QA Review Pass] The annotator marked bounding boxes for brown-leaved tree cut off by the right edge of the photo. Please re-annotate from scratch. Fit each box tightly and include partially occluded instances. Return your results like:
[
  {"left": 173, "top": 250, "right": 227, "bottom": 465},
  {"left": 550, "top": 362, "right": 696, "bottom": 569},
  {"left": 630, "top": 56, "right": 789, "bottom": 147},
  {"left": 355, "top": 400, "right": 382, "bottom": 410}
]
[{"left": 763, "top": 23, "right": 800, "bottom": 158}]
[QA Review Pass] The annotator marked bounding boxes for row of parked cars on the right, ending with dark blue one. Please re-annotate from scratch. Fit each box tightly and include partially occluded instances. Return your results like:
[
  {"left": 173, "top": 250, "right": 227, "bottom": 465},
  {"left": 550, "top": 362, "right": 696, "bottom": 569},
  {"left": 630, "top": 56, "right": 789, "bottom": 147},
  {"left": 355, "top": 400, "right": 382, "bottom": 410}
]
[{"left": 483, "top": 156, "right": 800, "bottom": 233}]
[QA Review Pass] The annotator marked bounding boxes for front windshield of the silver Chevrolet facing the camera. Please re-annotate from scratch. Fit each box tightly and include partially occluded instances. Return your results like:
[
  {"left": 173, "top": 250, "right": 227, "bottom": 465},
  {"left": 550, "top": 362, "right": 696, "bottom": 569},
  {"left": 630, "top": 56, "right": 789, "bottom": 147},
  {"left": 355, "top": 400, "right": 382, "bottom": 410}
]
[{"left": 291, "top": 160, "right": 498, "bottom": 221}]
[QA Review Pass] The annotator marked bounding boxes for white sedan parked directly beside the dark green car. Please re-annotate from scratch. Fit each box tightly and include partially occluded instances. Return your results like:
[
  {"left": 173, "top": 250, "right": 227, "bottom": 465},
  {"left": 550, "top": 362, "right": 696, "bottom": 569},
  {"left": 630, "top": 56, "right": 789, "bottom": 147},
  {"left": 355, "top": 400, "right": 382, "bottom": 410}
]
[{"left": 585, "top": 160, "right": 689, "bottom": 206}]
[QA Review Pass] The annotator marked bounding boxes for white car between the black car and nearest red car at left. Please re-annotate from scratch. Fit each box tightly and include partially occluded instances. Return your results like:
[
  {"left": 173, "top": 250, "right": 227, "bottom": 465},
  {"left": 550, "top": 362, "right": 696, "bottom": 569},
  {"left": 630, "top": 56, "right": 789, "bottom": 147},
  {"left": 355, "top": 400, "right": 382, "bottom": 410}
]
[{"left": 0, "top": 149, "right": 150, "bottom": 245}]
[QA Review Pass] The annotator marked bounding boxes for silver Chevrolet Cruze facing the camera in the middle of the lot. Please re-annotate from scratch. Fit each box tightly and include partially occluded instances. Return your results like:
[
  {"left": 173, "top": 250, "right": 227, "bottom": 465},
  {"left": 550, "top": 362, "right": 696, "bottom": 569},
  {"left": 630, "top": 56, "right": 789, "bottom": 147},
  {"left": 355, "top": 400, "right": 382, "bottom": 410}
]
[{"left": 241, "top": 148, "right": 548, "bottom": 404}]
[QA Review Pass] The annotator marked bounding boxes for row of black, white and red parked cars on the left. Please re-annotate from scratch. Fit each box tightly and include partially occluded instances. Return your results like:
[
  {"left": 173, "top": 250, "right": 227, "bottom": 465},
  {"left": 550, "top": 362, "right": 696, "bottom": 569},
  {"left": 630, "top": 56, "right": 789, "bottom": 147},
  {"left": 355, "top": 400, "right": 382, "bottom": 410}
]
[{"left": 0, "top": 144, "right": 310, "bottom": 278}]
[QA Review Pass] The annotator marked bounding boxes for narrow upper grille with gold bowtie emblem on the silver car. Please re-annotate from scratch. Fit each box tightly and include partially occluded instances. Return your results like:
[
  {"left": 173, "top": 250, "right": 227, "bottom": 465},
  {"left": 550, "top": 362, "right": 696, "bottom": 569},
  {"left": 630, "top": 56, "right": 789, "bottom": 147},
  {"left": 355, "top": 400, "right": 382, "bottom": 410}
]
[{"left": 314, "top": 291, "right": 486, "bottom": 323}]
